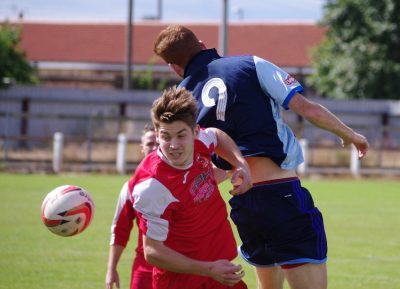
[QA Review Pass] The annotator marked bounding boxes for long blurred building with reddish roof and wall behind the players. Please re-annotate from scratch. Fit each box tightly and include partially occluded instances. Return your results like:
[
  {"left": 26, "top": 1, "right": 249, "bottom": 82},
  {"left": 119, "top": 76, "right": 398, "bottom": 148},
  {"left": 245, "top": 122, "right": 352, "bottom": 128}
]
[{"left": 18, "top": 21, "right": 324, "bottom": 88}]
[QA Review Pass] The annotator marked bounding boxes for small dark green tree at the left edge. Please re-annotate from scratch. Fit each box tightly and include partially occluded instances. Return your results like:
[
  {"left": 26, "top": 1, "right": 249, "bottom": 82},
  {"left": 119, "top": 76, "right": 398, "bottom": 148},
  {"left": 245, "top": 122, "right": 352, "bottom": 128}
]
[{"left": 0, "top": 22, "right": 38, "bottom": 89}]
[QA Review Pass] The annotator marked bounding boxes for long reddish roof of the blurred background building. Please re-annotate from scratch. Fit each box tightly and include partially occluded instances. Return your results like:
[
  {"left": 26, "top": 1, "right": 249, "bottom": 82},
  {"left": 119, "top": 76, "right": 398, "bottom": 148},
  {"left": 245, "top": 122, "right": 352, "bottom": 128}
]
[{"left": 21, "top": 21, "right": 325, "bottom": 67}]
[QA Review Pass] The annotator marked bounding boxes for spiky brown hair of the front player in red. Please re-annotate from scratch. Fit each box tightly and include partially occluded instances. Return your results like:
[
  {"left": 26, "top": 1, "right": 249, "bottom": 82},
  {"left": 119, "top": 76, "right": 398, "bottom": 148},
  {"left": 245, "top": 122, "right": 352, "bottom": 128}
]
[{"left": 151, "top": 86, "right": 197, "bottom": 129}]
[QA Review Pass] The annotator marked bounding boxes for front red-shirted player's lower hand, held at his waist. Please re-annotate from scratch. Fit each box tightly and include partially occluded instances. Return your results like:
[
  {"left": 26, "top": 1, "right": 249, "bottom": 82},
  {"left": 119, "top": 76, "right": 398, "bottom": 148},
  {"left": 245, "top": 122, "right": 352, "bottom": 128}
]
[{"left": 210, "top": 260, "right": 245, "bottom": 286}]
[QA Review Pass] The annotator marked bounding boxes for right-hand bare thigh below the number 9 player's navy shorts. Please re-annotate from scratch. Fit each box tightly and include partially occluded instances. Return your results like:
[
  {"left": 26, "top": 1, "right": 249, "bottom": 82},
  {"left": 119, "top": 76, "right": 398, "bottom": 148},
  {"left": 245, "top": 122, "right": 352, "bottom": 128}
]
[{"left": 283, "top": 263, "right": 327, "bottom": 289}]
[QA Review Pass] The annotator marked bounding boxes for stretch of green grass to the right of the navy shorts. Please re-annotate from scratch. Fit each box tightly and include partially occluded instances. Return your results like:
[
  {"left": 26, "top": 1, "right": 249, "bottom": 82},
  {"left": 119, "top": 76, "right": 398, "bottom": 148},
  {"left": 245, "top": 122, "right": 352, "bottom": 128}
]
[{"left": 305, "top": 180, "right": 400, "bottom": 289}]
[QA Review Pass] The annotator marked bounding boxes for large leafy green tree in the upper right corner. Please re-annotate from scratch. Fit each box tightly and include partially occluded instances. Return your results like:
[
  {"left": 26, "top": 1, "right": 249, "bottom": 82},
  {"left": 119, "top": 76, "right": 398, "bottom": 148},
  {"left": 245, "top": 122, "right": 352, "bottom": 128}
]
[{"left": 307, "top": 0, "right": 400, "bottom": 99}]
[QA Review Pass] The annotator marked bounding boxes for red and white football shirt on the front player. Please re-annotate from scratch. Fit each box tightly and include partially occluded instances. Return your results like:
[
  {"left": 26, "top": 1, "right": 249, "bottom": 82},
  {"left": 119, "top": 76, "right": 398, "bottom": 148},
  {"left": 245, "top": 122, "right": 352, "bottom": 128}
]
[{"left": 129, "top": 130, "right": 237, "bottom": 289}]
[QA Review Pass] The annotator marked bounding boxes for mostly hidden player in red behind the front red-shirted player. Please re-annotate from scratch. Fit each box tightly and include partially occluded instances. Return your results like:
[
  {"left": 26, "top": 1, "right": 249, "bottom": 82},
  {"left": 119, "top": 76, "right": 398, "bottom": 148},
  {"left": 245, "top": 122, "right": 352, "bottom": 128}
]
[{"left": 106, "top": 125, "right": 157, "bottom": 289}]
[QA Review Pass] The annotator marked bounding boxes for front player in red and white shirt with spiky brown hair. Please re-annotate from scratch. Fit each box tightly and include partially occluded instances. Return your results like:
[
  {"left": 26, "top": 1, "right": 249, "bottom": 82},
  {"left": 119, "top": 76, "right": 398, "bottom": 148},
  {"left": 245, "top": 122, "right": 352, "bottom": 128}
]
[{"left": 129, "top": 88, "right": 251, "bottom": 289}]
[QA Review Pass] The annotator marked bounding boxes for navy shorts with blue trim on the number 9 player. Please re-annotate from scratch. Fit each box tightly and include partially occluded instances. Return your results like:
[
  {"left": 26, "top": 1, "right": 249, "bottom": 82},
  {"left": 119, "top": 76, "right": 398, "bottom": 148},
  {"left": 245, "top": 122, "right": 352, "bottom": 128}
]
[{"left": 229, "top": 178, "right": 327, "bottom": 267}]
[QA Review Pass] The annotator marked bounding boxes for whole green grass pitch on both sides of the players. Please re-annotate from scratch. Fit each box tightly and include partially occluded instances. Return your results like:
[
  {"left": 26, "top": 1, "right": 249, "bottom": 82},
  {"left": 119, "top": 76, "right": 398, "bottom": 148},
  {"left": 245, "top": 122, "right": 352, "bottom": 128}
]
[{"left": 0, "top": 174, "right": 400, "bottom": 289}]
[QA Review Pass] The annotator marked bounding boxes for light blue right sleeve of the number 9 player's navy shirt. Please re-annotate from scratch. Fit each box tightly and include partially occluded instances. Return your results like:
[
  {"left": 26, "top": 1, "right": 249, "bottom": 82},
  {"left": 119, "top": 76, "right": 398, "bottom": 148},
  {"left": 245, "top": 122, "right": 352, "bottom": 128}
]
[{"left": 253, "top": 56, "right": 303, "bottom": 109}]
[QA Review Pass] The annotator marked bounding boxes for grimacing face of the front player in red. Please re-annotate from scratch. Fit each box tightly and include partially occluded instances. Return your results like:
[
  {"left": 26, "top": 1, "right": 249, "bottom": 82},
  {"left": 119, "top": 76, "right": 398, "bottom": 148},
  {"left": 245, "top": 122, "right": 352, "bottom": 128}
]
[{"left": 157, "top": 120, "right": 199, "bottom": 168}]
